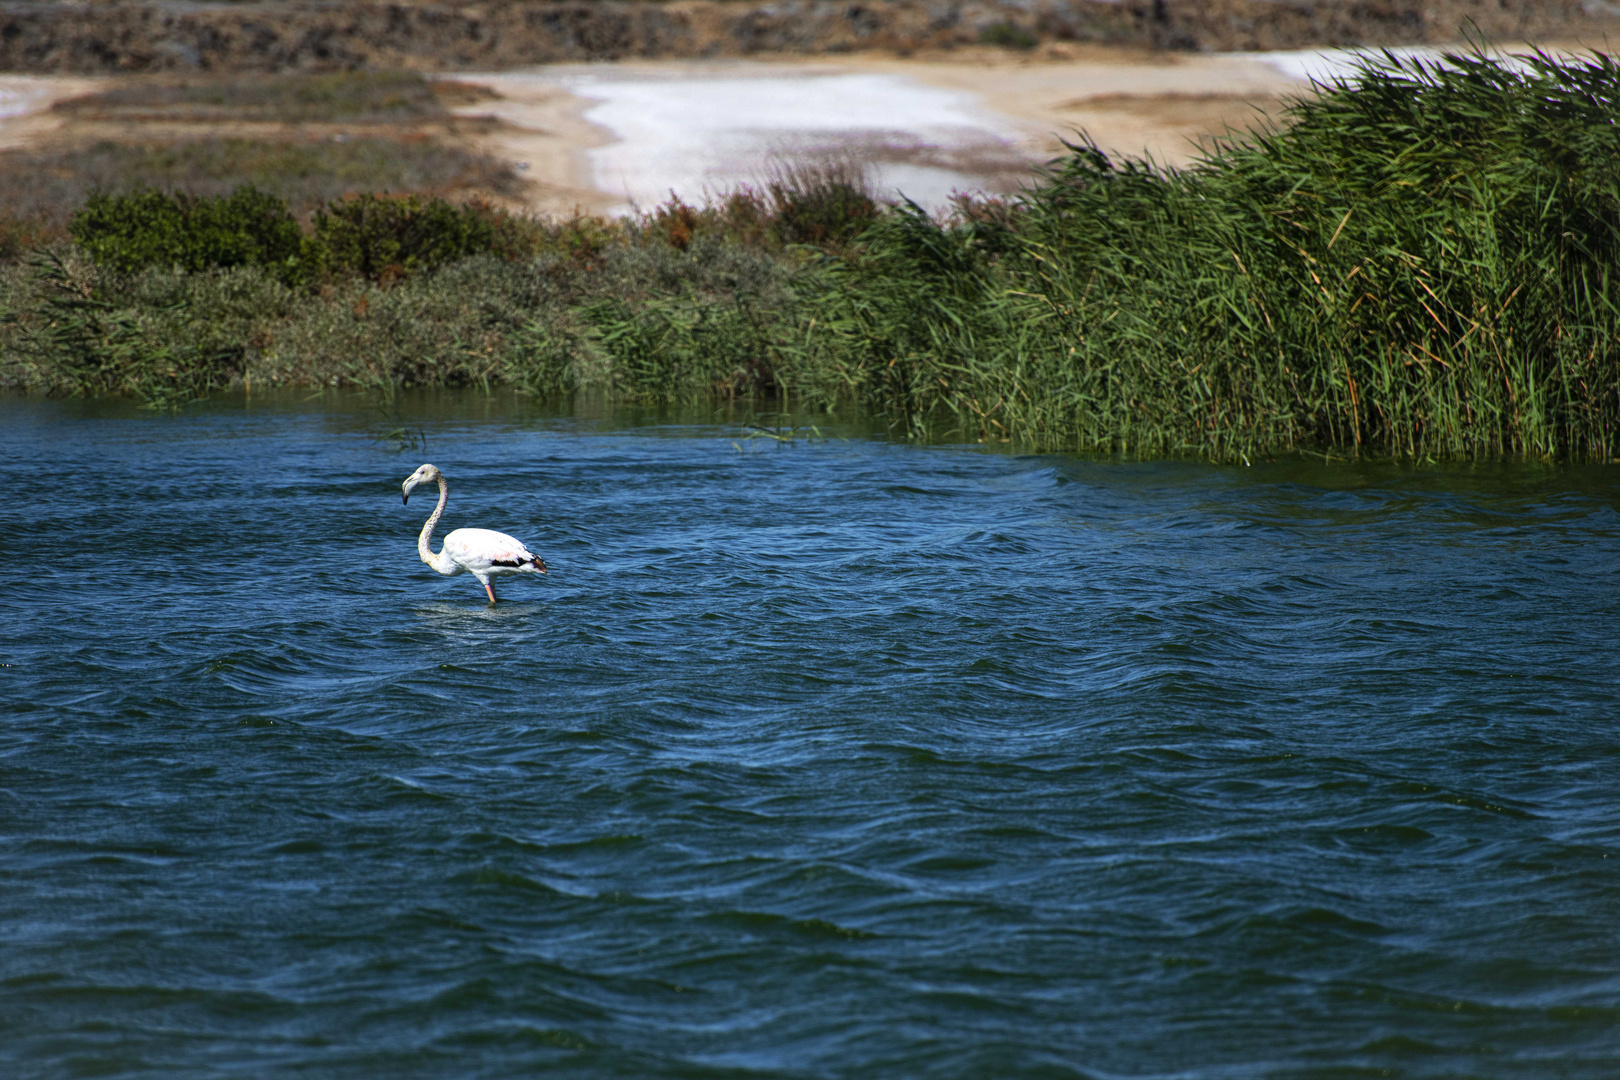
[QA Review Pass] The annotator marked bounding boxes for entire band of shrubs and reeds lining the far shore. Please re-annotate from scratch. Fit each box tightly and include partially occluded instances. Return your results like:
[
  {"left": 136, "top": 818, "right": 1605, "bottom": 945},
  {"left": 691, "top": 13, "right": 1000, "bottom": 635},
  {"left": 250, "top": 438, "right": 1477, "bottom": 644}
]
[{"left": 0, "top": 52, "right": 1620, "bottom": 461}]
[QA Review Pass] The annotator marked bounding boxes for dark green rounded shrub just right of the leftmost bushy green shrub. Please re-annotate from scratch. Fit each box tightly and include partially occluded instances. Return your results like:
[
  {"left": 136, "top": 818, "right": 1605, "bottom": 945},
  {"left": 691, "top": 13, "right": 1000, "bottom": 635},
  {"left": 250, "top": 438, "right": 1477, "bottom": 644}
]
[{"left": 313, "top": 194, "right": 501, "bottom": 282}]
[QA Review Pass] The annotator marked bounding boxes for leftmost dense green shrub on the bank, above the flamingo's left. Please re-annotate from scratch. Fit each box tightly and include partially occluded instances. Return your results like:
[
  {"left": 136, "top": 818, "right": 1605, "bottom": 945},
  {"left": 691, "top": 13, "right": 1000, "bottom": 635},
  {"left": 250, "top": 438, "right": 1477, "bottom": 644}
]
[{"left": 68, "top": 185, "right": 303, "bottom": 275}]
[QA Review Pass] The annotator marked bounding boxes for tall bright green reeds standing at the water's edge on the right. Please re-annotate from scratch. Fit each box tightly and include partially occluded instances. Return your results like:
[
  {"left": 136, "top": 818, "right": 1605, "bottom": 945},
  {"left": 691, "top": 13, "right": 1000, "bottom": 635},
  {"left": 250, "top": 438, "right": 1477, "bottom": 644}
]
[{"left": 793, "top": 45, "right": 1620, "bottom": 460}]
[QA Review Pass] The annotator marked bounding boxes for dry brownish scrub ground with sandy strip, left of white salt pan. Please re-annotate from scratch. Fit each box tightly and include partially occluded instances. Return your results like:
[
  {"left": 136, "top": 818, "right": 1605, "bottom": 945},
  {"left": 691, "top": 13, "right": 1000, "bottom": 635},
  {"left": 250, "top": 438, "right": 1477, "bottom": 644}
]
[{"left": 0, "top": 71, "right": 525, "bottom": 235}]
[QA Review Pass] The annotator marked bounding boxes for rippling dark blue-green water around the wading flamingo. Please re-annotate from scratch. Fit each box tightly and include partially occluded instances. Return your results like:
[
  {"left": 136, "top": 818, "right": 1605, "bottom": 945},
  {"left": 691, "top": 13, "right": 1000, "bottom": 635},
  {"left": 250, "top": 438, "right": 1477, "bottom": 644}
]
[{"left": 0, "top": 397, "right": 1620, "bottom": 1078}]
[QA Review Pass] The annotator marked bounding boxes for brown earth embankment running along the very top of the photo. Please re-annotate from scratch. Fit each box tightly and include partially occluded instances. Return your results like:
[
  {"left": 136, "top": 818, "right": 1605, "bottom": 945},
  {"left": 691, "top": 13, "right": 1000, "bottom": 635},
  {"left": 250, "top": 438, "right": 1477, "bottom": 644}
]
[{"left": 0, "top": 0, "right": 1620, "bottom": 74}]
